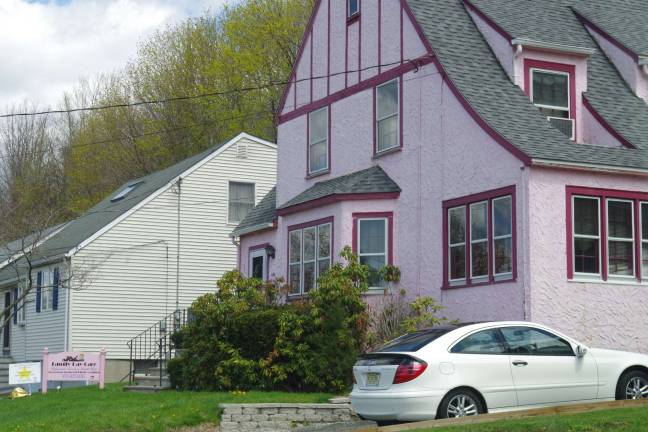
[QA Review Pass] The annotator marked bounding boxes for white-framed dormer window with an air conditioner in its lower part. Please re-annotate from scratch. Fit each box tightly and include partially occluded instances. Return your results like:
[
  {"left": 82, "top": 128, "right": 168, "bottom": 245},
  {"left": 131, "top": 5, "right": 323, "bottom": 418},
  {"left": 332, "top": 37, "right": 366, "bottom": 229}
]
[{"left": 530, "top": 68, "right": 574, "bottom": 139}]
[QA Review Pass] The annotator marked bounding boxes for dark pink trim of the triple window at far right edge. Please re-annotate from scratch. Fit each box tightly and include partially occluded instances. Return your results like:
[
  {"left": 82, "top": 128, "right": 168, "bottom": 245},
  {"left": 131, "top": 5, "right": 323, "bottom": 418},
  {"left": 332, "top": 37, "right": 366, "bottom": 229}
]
[{"left": 565, "top": 186, "right": 648, "bottom": 281}]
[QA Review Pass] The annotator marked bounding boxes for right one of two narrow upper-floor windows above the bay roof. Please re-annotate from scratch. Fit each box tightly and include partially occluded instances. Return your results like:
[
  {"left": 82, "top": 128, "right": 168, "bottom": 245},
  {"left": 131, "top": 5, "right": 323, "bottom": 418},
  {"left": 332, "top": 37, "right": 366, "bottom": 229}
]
[{"left": 375, "top": 78, "right": 400, "bottom": 153}]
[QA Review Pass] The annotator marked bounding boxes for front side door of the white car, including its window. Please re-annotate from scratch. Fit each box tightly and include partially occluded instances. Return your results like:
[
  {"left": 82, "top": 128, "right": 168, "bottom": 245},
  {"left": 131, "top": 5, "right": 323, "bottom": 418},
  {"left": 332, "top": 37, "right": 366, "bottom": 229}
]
[{"left": 500, "top": 326, "right": 598, "bottom": 406}]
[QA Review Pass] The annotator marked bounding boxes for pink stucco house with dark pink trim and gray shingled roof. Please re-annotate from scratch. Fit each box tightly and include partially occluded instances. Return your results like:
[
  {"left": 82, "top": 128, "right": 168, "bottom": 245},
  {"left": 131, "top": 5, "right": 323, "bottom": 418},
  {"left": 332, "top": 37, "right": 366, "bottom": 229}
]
[{"left": 232, "top": 0, "right": 648, "bottom": 352}]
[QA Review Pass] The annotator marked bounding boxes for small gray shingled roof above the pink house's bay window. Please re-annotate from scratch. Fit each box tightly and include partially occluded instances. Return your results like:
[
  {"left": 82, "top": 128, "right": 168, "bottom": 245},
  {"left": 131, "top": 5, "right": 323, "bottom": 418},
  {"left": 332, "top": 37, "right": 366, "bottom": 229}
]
[{"left": 279, "top": 165, "right": 401, "bottom": 209}]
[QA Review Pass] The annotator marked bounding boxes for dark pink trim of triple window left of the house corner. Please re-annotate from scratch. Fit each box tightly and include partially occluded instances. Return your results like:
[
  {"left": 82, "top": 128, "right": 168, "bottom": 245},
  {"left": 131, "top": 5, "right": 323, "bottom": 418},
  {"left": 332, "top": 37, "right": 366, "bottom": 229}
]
[{"left": 441, "top": 185, "right": 517, "bottom": 290}]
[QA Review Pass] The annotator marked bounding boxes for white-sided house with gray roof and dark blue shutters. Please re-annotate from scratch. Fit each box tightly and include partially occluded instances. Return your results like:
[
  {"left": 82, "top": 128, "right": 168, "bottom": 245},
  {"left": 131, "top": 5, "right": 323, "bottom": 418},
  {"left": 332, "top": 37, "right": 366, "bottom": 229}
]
[{"left": 0, "top": 134, "right": 277, "bottom": 380}]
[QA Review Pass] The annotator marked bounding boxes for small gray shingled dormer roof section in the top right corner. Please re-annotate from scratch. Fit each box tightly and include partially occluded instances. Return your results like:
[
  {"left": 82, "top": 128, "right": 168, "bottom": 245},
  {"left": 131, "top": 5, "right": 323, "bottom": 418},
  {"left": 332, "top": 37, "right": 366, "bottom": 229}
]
[{"left": 572, "top": 0, "right": 648, "bottom": 56}]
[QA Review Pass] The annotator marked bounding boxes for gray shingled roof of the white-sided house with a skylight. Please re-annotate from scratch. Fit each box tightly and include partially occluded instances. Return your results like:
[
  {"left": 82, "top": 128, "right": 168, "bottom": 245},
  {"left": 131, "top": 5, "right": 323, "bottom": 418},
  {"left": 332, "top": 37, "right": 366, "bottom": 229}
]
[{"left": 0, "top": 137, "right": 233, "bottom": 281}]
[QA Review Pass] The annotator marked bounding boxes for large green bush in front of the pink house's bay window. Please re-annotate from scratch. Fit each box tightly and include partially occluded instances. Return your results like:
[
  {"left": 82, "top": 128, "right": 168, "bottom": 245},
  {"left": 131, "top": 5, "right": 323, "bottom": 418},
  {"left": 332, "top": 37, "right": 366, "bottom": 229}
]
[{"left": 169, "top": 248, "right": 369, "bottom": 391}]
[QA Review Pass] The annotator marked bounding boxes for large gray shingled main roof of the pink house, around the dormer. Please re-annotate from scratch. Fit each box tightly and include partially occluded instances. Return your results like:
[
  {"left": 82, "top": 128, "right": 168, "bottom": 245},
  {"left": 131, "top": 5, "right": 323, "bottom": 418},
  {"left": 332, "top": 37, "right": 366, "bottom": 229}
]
[{"left": 408, "top": 0, "right": 648, "bottom": 169}]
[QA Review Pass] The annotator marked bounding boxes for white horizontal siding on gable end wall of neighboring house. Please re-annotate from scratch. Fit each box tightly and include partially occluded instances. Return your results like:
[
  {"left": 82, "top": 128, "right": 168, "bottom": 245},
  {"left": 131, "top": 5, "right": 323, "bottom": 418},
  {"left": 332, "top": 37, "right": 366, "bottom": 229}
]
[{"left": 70, "top": 138, "right": 277, "bottom": 359}]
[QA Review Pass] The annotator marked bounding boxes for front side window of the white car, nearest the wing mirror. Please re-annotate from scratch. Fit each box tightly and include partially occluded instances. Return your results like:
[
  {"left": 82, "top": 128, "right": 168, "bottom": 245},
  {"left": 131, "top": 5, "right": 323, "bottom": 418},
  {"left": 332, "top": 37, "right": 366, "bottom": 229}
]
[{"left": 500, "top": 327, "right": 574, "bottom": 356}]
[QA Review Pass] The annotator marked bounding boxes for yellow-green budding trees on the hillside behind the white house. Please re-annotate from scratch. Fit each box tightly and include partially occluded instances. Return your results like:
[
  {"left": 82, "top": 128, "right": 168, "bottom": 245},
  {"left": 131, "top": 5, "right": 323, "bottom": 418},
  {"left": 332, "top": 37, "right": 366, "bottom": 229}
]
[{"left": 0, "top": 0, "right": 313, "bottom": 241}]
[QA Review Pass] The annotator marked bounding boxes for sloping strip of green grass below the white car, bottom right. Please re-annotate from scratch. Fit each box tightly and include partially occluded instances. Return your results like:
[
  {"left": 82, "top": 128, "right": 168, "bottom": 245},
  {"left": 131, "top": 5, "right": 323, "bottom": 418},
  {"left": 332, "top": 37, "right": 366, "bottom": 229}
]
[{"left": 418, "top": 407, "right": 648, "bottom": 432}]
